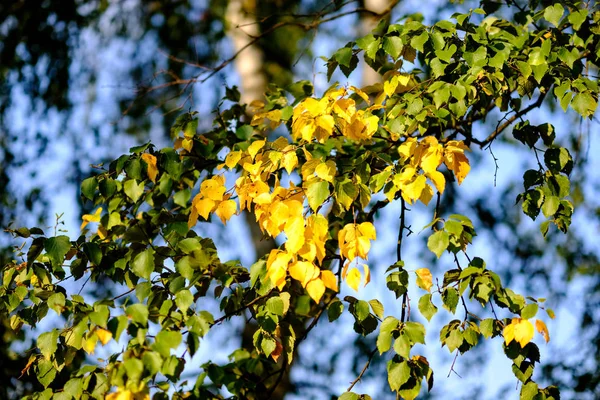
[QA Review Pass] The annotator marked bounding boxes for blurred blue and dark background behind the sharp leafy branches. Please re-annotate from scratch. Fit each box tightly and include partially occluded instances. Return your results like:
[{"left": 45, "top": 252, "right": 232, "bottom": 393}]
[{"left": 0, "top": 0, "right": 600, "bottom": 399}]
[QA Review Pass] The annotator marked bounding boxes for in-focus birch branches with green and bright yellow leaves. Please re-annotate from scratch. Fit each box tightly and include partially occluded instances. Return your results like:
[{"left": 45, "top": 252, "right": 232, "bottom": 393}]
[{"left": 0, "top": 1, "right": 600, "bottom": 400}]
